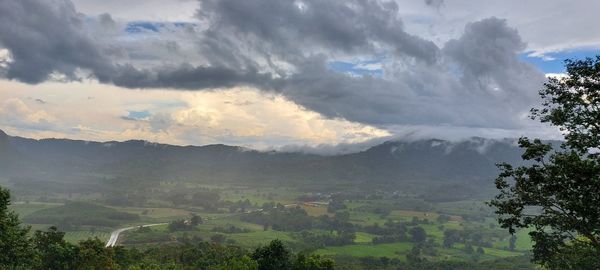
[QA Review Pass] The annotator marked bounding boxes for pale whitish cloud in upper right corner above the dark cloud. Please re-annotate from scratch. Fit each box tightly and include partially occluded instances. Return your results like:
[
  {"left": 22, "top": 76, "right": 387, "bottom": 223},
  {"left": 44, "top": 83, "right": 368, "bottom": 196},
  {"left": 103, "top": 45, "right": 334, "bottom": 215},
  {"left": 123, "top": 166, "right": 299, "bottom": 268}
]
[{"left": 396, "top": 0, "right": 600, "bottom": 54}]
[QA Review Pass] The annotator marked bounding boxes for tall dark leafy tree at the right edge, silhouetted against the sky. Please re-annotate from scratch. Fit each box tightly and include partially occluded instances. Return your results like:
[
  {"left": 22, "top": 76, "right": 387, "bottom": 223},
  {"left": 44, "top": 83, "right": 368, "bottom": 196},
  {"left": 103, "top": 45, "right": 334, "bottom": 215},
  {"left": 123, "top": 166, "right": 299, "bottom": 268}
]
[{"left": 490, "top": 56, "right": 600, "bottom": 269}]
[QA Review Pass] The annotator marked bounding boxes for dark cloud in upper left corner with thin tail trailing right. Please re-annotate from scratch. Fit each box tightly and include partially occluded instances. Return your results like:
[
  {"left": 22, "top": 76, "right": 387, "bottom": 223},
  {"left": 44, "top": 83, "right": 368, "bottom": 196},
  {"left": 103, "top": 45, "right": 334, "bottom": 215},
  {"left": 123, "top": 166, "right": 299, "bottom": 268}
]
[{"left": 0, "top": 0, "right": 265, "bottom": 88}]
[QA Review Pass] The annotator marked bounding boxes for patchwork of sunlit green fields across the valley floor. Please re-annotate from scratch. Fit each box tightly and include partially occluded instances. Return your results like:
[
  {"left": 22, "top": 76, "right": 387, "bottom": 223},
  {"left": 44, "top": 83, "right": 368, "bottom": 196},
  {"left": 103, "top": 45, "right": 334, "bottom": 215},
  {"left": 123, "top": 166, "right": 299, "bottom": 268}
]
[{"left": 11, "top": 183, "right": 531, "bottom": 261}]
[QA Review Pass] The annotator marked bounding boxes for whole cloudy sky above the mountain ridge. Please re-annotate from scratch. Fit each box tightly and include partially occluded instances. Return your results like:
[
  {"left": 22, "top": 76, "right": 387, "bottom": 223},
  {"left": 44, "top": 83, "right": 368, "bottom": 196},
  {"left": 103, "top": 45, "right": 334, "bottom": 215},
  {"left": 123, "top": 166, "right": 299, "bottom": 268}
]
[{"left": 0, "top": 0, "right": 600, "bottom": 149}]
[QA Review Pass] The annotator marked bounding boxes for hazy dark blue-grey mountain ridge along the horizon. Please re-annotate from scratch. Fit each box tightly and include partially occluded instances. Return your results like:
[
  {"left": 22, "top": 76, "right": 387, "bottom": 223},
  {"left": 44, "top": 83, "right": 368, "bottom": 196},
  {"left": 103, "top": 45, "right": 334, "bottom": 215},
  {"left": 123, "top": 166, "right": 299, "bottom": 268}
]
[{"left": 0, "top": 131, "right": 536, "bottom": 196}]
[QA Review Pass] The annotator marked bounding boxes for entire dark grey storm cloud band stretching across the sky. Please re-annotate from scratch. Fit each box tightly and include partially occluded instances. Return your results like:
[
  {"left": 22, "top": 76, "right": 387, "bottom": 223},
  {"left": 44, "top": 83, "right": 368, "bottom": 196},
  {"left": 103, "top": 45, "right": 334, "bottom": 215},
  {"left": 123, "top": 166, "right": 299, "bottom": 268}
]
[{"left": 0, "top": 0, "right": 544, "bottom": 131}]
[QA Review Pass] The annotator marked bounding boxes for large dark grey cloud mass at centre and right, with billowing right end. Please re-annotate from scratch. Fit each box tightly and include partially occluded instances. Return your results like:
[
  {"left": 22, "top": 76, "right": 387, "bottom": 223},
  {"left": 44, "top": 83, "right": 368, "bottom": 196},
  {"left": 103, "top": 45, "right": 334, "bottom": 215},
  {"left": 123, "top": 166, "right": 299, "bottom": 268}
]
[{"left": 186, "top": 0, "right": 544, "bottom": 128}]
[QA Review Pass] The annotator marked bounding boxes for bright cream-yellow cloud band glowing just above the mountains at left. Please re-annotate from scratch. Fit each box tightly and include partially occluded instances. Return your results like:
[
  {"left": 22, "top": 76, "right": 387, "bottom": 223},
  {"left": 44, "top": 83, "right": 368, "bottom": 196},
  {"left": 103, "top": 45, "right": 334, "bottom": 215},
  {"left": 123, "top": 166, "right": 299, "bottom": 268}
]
[{"left": 0, "top": 80, "right": 390, "bottom": 149}]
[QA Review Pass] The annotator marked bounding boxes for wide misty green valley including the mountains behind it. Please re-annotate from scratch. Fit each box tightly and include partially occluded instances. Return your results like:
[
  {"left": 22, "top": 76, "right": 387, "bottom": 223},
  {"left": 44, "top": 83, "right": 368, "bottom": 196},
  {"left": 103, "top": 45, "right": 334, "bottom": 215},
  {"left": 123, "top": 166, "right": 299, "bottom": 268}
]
[{"left": 2, "top": 130, "right": 531, "bottom": 268}]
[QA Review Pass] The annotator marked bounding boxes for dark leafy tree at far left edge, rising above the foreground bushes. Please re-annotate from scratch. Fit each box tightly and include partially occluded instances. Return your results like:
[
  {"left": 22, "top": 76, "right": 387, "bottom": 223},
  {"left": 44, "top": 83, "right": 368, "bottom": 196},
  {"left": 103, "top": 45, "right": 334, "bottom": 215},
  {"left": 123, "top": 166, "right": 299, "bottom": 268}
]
[{"left": 0, "top": 187, "right": 33, "bottom": 269}]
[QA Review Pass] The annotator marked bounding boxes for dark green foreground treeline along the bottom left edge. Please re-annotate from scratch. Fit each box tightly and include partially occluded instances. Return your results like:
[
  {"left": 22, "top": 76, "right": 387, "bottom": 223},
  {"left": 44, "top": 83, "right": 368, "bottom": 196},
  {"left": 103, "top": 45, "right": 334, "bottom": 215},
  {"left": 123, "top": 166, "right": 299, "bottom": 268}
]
[{"left": 0, "top": 187, "right": 334, "bottom": 270}]
